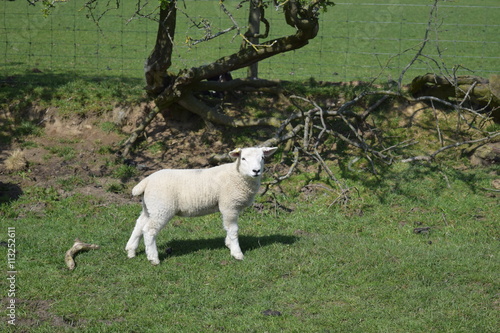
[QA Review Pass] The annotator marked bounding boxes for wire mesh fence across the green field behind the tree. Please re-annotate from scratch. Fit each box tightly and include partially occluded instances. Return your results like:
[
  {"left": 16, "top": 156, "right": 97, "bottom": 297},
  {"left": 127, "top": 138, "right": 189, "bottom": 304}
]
[{"left": 0, "top": 0, "right": 500, "bottom": 81}]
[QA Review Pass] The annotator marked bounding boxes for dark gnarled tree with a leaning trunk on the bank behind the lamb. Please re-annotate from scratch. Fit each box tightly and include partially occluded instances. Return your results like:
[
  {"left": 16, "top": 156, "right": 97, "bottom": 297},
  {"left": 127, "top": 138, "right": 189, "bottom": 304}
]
[{"left": 123, "top": 0, "right": 333, "bottom": 155}]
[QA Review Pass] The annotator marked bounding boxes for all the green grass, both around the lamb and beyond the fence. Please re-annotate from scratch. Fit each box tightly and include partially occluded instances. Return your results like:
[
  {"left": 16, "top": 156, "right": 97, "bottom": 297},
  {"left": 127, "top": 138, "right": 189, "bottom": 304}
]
[{"left": 0, "top": 0, "right": 500, "bottom": 333}]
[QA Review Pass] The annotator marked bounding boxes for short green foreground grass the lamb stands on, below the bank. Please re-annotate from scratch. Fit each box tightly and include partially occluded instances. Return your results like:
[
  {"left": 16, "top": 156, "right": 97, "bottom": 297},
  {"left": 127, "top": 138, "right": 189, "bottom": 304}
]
[{"left": 0, "top": 160, "right": 500, "bottom": 332}]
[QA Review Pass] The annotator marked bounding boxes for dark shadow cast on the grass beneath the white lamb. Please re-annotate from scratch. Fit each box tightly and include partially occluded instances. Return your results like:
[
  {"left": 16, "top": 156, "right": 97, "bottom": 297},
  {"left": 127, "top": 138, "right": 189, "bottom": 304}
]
[{"left": 158, "top": 235, "right": 298, "bottom": 261}]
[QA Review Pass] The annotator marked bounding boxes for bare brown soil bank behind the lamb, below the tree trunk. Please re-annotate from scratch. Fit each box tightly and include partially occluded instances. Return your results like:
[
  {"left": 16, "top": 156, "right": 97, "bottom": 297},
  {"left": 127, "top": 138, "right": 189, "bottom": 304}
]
[{"left": 0, "top": 104, "right": 239, "bottom": 203}]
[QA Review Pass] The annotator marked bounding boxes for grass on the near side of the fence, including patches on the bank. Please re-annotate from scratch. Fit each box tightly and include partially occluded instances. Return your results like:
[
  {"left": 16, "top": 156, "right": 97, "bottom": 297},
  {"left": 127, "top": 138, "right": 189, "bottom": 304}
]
[{"left": 0, "top": 80, "right": 500, "bottom": 333}]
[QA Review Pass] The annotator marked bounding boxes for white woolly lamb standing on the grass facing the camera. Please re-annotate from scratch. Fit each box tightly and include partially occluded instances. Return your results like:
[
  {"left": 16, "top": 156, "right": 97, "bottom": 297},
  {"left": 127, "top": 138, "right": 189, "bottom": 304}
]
[{"left": 125, "top": 147, "right": 277, "bottom": 265}]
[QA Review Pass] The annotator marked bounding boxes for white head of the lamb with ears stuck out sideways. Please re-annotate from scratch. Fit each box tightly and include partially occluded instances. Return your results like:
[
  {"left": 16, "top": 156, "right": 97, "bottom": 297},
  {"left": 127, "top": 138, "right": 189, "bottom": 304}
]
[{"left": 229, "top": 147, "right": 278, "bottom": 178}]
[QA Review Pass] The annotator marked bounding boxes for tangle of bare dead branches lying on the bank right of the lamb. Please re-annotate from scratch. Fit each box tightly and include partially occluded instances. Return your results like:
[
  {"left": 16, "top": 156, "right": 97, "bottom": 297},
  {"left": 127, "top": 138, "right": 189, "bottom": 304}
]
[{"left": 259, "top": 80, "right": 500, "bottom": 204}]
